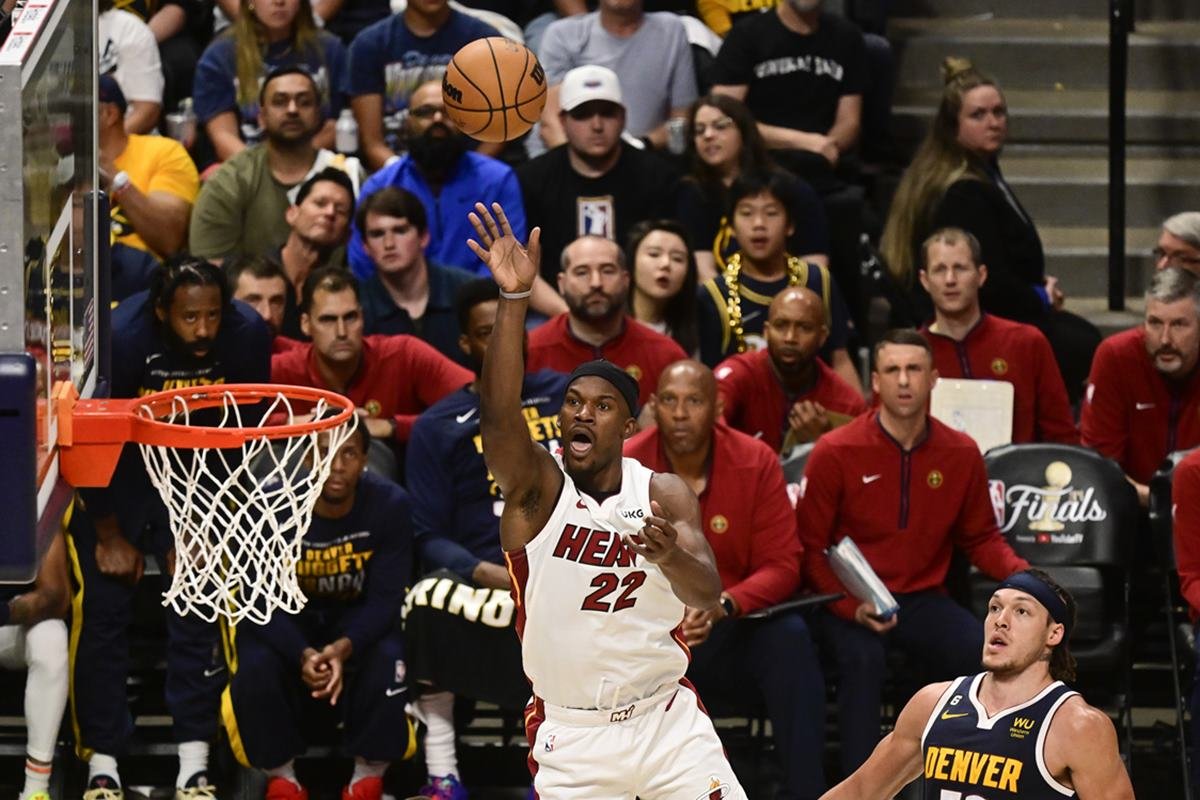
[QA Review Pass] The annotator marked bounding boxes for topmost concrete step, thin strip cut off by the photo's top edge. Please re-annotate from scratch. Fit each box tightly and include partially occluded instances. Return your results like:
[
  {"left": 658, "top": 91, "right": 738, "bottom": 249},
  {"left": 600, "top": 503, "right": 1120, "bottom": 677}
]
[{"left": 892, "top": 0, "right": 1200, "bottom": 19}]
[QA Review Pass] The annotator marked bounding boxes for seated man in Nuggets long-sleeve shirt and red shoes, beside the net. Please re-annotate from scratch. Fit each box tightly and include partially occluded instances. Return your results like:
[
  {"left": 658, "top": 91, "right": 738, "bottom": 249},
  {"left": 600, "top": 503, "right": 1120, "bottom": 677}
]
[{"left": 223, "top": 425, "right": 415, "bottom": 800}]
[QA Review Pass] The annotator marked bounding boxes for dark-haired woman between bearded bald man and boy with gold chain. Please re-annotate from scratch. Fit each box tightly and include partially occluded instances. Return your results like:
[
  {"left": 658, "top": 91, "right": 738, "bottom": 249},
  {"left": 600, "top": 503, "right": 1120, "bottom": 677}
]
[{"left": 625, "top": 219, "right": 700, "bottom": 355}]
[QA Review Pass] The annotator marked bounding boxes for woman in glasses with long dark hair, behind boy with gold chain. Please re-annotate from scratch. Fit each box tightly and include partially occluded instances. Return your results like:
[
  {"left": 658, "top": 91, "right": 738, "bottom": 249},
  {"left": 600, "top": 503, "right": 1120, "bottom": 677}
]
[{"left": 678, "top": 95, "right": 829, "bottom": 283}]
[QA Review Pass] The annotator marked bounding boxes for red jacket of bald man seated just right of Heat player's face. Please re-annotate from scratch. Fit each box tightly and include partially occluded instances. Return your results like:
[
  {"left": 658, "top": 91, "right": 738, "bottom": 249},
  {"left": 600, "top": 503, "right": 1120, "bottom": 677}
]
[{"left": 625, "top": 422, "right": 802, "bottom": 613}]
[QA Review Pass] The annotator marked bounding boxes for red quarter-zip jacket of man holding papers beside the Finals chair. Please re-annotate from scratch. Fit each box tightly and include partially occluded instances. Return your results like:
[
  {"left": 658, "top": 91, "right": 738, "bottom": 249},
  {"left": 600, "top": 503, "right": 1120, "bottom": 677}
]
[{"left": 796, "top": 413, "right": 1028, "bottom": 619}]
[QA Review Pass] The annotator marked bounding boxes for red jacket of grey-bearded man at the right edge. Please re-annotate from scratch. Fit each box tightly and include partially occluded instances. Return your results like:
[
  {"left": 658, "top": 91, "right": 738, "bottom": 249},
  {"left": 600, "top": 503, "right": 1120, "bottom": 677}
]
[{"left": 1080, "top": 327, "right": 1200, "bottom": 483}]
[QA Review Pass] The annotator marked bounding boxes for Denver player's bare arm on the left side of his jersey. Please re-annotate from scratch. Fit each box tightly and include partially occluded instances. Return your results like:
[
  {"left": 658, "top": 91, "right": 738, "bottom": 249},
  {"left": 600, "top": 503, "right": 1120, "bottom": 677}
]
[{"left": 821, "top": 684, "right": 949, "bottom": 800}]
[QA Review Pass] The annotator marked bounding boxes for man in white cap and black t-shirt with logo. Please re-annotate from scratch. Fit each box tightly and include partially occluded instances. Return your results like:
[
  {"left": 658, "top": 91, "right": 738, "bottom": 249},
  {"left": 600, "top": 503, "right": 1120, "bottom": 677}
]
[{"left": 517, "top": 66, "right": 677, "bottom": 285}]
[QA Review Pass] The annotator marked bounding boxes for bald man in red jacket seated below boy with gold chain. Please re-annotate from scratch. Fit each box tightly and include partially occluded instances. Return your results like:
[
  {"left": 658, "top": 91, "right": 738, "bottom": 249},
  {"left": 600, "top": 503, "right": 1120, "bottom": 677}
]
[{"left": 714, "top": 287, "right": 866, "bottom": 453}]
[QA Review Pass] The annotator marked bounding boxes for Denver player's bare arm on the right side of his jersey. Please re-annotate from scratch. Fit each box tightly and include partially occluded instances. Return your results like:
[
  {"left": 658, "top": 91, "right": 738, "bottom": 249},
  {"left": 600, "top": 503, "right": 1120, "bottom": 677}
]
[{"left": 1045, "top": 697, "right": 1134, "bottom": 800}]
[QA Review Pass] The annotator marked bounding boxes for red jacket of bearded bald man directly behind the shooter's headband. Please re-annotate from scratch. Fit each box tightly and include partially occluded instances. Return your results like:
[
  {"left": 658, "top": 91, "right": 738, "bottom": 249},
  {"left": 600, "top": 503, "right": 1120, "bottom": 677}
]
[{"left": 526, "top": 313, "right": 688, "bottom": 404}]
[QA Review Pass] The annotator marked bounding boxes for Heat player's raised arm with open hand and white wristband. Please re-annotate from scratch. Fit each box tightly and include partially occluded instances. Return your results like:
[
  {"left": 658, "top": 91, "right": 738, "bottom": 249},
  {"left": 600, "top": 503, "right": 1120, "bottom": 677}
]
[{"left": 467, "top": 203, "right": 563, "bottom": 551}]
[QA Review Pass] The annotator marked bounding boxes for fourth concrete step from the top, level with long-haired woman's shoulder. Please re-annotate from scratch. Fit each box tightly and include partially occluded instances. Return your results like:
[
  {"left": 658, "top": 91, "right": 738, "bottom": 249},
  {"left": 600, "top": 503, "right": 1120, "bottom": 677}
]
[{"left": 1002, "top": 156, "right": 1200, "bottom": 228}]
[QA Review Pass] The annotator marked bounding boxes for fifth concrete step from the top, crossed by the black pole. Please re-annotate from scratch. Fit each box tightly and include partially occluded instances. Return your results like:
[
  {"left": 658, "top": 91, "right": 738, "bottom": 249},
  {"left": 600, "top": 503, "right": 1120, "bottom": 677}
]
[{"left": 1038, "top": 224, "right": 1159, "bottom": 296}]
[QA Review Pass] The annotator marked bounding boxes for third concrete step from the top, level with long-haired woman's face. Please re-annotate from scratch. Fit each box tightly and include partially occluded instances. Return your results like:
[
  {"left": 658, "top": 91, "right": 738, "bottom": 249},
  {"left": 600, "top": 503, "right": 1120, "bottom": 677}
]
[{"left": 892, "top": 88, "right": 1200, "bottom": 149}]
